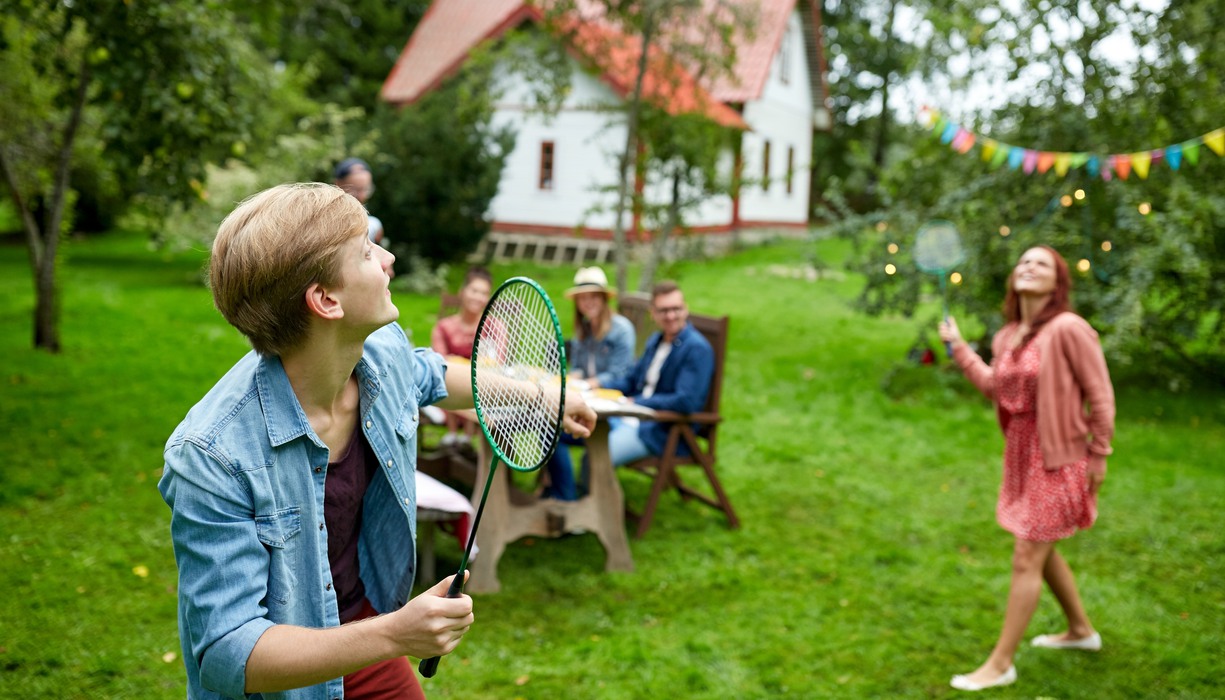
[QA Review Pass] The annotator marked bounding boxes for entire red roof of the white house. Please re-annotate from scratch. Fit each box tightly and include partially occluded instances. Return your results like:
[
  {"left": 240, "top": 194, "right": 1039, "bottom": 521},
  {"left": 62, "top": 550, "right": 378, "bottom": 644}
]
[{"left": 382, "top": 0, "right": 818, "bottom": 129}]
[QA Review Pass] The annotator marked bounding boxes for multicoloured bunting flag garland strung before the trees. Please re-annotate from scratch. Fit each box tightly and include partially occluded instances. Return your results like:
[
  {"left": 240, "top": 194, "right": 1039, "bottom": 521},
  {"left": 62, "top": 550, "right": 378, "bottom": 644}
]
[{"left": 919, "top": 107, "right": 1225, "bottom": 180}]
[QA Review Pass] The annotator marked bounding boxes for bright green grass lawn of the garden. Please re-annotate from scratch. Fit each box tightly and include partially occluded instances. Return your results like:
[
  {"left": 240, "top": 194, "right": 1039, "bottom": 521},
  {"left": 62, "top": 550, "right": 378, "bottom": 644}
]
[{"left": 0, "top": 234, "right": 1225, "bottom": 699}]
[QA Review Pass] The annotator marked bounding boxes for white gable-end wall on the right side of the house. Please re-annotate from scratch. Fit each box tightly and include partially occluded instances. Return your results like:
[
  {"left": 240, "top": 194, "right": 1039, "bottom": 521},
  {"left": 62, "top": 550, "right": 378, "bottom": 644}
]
[{"left": 740, "top": 12, "right": 812, "bottom": 223}]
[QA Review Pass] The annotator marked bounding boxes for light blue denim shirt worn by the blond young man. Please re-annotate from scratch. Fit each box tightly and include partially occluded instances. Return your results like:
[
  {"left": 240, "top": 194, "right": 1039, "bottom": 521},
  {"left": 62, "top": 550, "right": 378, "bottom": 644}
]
[{"left": 158, "top": 324, "right": 446, "bottom": 700}]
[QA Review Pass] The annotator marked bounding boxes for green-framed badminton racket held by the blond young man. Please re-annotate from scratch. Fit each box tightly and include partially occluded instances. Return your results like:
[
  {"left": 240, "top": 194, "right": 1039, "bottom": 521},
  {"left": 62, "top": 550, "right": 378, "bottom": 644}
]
[{"left": 419, "top": 277, "right": 566, "bottom": 678}]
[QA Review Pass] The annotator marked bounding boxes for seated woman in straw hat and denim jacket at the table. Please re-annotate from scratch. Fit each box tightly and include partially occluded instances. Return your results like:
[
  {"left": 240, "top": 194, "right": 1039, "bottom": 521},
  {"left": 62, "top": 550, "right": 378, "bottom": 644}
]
[{"left": 544, "top": 267, "right": 637, "bottom": 500}]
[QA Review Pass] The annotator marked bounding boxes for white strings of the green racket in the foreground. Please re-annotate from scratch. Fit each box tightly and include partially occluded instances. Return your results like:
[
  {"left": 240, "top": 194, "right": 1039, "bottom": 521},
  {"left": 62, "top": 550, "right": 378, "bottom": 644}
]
[{"left": 475, "top": 286, "right": 562, "bottom": 470}]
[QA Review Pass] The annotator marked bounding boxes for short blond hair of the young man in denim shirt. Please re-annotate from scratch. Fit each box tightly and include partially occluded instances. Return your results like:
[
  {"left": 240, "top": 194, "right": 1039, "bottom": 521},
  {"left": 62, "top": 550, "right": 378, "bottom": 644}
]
[{"left": 208, "top": 183, "right": 368, "bottom": 356}]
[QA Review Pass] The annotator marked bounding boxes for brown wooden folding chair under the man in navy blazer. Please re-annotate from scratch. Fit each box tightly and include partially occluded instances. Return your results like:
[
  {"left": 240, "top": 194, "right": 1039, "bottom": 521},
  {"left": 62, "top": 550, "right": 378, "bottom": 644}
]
[{"left": 619, "top": 298, "right": 740, "bottom": 538}]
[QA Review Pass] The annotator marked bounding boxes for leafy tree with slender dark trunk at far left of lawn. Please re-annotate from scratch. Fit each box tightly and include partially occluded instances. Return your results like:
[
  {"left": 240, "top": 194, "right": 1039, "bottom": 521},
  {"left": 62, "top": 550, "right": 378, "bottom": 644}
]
[{"left": 0, "top": 0, "right": 280, "bottom": 352}]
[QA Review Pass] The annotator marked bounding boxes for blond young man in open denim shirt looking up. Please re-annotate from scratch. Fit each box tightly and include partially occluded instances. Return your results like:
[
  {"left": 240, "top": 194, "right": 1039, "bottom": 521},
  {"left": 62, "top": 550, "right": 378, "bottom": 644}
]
[{"left": 158, "top": 184, "right": 595, "bottom": 700}]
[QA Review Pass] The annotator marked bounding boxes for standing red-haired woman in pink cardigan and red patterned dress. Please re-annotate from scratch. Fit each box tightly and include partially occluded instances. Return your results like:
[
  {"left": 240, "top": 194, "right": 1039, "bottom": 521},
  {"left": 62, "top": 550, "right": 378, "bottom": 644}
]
[{"left": 940, "top": 245, "right": 1115, "bottom": 690}]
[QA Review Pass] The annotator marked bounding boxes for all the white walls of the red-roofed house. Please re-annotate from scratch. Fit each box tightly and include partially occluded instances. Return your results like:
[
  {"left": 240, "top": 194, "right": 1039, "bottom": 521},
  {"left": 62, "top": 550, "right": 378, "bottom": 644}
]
[{"left": 490, "top": 12, "right": 812, "bottom": 235}]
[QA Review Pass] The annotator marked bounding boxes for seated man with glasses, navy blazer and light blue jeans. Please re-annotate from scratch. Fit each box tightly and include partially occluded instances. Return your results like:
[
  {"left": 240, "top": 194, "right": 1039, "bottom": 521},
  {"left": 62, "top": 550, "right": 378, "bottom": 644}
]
[{"left": 588, "top": 282, "right": 714, "bottom": 465}]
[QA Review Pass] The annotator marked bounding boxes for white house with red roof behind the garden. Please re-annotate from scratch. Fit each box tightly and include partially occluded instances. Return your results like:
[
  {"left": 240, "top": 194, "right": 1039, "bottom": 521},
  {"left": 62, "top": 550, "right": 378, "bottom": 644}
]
[{"left": 382, "top": 0, "right": 831, "bottom": 262}]
